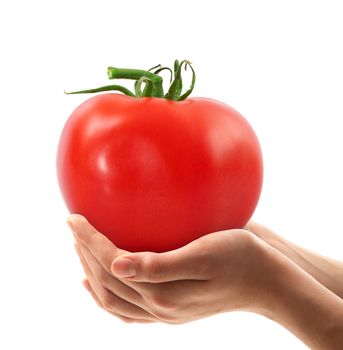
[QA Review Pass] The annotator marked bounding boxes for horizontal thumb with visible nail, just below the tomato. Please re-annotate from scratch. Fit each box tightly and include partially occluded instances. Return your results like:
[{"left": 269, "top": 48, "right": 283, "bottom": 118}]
[{"left": 111, "top": 244, "right": 209, "bottom": 283}]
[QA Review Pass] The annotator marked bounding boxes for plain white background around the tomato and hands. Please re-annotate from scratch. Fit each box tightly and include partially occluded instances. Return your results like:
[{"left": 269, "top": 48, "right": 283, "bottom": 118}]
[{"left": 0, "top": 0, "right": 343, "bottom": 350}]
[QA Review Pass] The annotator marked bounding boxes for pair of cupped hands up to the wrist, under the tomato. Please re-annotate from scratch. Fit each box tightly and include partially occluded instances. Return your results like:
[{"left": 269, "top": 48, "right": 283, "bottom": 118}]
[{"left": 69, "top": 215, "right": 284, "bottom": 324}]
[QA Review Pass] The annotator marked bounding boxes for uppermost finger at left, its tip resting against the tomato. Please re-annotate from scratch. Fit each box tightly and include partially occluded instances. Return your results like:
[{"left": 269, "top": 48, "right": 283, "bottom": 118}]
[{"left": 67, "top": 214, "right": 126, "bottom": 273}]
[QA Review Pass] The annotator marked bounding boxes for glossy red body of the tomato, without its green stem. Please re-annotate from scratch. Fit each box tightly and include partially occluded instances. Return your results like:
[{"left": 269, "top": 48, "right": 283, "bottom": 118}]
[{"left": 57, "top": 93, "right": 263, "bottom": 252}]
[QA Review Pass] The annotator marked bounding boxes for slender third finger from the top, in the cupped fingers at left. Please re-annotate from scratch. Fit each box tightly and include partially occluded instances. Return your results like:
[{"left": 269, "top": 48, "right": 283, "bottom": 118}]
[{"left": 78, "top": 243, "right": 157, "bottom": 321}]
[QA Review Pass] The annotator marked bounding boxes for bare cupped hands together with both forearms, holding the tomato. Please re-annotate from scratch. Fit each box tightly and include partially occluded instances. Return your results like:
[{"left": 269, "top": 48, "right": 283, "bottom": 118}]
[{"left": 68, "top": 215, "right": 343, "bottom": 350}]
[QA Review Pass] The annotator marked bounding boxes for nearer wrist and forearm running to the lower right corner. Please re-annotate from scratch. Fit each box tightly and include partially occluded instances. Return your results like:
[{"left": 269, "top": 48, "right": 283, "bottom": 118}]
[{"left": 259, "top": 246, "right": 343, "bottom": 350}]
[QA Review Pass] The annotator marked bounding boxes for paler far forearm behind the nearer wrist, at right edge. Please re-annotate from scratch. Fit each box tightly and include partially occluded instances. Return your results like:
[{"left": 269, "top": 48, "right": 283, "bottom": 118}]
[{"left": 245, "top": 221, "right": 343, "bottom": 299}]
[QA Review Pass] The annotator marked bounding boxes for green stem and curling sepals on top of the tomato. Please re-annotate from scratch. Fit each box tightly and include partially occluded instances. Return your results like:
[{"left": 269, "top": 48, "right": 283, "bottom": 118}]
[{"left": 65, "top": 60, "right": 196, "bottom": 101}]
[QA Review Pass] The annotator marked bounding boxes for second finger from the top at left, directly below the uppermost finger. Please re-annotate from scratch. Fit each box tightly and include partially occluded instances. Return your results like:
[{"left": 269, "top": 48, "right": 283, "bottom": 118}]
[{"left": 78, "top": 244, "right": 143, "bottom": 307}]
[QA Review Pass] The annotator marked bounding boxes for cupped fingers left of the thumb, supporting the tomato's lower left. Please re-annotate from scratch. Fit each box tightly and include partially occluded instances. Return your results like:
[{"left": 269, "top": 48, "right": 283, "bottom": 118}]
[{"left": 67, "top": 214, "right": 156, "bottom": 323}]
